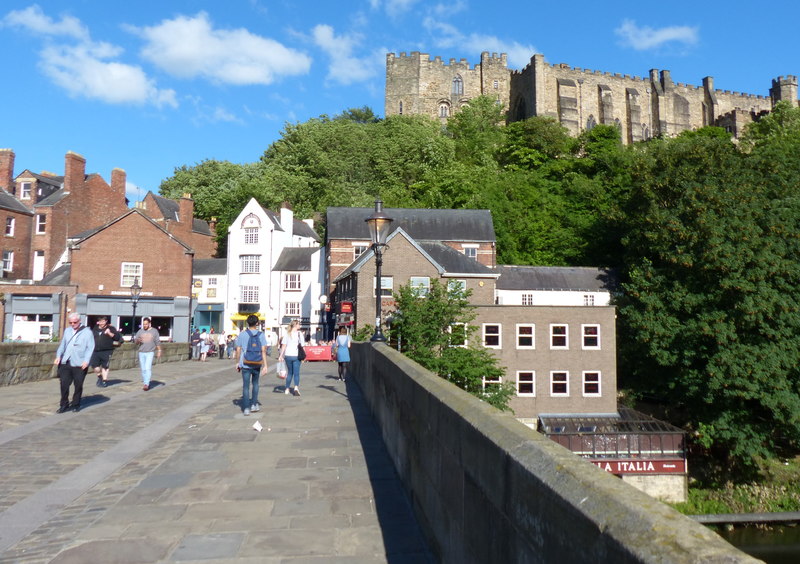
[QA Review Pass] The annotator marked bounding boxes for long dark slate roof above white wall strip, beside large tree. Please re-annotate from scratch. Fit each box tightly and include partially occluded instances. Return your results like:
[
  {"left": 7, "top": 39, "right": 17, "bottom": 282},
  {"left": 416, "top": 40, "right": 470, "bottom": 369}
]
[{"left": 496, "top": 266, "right": 617, "bottom": 292}]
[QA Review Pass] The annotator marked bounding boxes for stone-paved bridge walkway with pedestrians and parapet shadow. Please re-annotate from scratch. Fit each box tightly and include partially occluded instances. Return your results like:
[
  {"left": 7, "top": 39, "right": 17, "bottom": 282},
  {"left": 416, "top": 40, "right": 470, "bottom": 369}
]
[{"left": 0, "top": 359, "right": 435, "bottom": 564}]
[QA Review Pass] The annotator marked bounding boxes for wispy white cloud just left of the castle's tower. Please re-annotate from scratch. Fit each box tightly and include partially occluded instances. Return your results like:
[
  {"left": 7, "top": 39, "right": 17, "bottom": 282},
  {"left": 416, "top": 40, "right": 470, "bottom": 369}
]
[{"left": 311, "top": 25, "right": 385, "bottom": 85}]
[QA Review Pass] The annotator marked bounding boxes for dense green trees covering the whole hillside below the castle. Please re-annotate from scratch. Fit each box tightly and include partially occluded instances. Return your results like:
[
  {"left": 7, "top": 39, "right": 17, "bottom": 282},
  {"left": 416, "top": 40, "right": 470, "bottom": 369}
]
[{"left": 161, "top": 98, "right": 800, "bottom": 468}]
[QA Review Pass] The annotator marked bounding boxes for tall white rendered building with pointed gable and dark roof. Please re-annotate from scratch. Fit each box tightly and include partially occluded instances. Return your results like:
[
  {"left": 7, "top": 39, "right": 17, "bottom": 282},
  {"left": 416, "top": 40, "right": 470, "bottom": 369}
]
[{"left": 225, "top": 199, "right": 325, "bottom": 337}]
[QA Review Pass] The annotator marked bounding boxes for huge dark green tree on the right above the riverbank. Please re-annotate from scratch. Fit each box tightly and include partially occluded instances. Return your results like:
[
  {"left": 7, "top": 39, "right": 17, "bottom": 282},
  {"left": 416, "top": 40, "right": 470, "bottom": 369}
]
[{"left": 619, "top": 134, "right": 800, "bottom": 468}]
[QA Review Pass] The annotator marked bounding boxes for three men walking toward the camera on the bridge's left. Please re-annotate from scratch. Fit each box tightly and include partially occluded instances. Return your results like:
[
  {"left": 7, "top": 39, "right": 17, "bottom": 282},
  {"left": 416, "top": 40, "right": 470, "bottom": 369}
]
[{"left": 53, "top": 313, "right": 161, "bottom": 413}]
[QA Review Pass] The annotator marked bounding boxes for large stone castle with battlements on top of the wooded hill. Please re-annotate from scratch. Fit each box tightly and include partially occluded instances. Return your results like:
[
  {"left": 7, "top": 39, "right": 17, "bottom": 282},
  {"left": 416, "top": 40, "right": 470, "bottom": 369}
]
[{"left": 385, "top": 51, "right": 798, "bottom": 143}]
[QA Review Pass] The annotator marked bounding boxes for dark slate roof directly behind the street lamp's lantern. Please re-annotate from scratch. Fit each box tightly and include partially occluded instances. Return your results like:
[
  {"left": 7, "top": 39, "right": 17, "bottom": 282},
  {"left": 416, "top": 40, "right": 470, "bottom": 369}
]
[{"left": 326, "top": 208, "right": 496, "bottom": 242}]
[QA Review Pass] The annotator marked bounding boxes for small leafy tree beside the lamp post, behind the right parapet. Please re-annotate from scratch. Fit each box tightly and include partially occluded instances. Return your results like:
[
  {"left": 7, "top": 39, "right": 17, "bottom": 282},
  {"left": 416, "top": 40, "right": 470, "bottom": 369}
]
[{"left": 392, "top": 279, "right": 514, "bottom": 410}]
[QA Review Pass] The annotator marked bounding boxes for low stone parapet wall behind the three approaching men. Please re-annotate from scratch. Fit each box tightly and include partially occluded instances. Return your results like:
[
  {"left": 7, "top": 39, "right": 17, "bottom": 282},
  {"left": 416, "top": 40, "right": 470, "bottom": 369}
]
[{"left": 0, "top": 343, "right": 189, "bottom": 387}]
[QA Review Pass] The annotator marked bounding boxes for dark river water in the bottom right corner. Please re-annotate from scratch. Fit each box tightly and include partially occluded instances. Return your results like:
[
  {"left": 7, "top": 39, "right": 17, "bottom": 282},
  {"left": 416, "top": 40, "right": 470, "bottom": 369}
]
[{"left": 717, "top": 525, "right": 800, "bottom": 564}]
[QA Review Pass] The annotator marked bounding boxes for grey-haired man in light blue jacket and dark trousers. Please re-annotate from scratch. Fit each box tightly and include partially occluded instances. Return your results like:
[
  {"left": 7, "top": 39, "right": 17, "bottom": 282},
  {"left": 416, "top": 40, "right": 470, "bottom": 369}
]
[{"left": 53, "top": 313, "right": 94, "bottom": 413}]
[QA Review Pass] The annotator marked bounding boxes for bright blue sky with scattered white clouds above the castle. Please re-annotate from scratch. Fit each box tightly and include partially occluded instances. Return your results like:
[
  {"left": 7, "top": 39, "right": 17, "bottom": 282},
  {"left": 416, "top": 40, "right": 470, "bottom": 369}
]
[{"left": 0, "top": 0, "right": 800, "bottom": 201}]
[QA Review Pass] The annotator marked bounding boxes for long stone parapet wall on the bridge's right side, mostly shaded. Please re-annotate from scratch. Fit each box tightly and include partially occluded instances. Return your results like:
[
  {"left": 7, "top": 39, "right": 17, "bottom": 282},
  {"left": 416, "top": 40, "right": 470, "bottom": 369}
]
[{"left": 351, "top": 343, "right": 757, "bottom": 563}]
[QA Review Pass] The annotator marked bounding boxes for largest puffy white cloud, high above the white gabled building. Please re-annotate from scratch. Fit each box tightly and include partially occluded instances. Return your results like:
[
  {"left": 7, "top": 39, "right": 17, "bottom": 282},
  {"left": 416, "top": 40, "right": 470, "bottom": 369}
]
[{"left": 128, "top": 12, "right": 311, "bottom": 85}]
